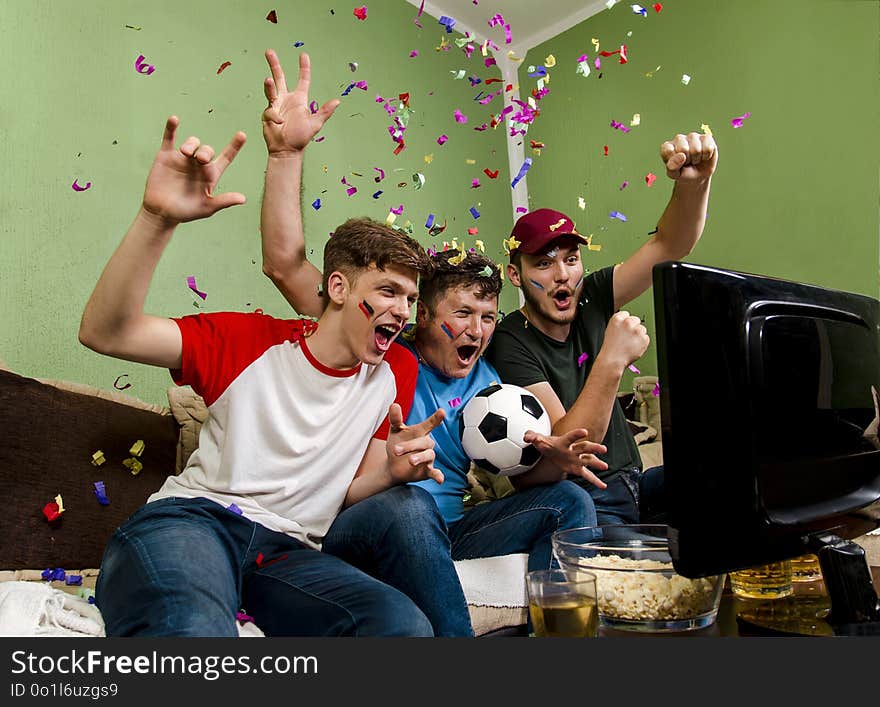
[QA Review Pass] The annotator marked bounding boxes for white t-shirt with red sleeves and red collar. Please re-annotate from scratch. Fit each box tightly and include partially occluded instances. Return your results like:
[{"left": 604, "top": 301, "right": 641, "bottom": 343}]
[{"left": 148, "top": 312, "right": 418, "bottom": 549}]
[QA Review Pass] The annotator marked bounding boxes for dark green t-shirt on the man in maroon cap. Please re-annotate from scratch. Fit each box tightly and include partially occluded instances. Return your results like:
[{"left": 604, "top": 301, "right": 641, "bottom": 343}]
[{"left": 486, "top": 266, "right": 642, "bottom": 482}]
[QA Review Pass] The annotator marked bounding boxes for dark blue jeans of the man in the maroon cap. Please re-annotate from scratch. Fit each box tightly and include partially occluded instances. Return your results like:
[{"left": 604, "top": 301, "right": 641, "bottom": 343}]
[{"left": 587, "top": 466, "right": 666, "bottom": 525}]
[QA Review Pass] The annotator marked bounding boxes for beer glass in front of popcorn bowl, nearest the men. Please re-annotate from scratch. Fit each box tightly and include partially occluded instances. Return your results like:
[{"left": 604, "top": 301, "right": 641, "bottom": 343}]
[{"left": 526, "top": 569, "right": 599, "bottom": 638}]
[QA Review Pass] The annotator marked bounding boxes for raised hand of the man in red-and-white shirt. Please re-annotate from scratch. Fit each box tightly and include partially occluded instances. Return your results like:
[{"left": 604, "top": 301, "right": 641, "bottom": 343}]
[{"left": 143, "top": 115, "right": 247, "bottom": 225}]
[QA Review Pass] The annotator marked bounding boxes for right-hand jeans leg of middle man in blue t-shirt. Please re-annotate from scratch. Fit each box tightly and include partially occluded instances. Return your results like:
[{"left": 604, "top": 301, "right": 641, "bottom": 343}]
[{"left": 449, "top": 481, "right": 596, "bottom": 571}]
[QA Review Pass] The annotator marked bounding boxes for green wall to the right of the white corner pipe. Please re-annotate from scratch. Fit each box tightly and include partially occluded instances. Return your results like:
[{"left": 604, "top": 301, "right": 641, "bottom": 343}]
[{"left": 520, "top": 0, "right": 880, "bottom": 388}]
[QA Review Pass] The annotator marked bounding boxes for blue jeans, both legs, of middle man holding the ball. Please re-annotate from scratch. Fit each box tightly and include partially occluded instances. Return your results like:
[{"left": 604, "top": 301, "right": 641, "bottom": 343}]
[{"left": 323, "top": 481, "right": 596, "bottom": 636}]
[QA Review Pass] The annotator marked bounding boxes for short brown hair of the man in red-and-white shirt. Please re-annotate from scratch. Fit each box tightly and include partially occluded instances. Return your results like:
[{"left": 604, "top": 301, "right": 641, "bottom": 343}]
[{"left": 321, "top": 218, "right": 433, "bottom": 307}]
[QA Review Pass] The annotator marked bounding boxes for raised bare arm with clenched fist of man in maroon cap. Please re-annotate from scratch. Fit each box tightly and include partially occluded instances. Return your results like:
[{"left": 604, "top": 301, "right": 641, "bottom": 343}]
[{"left": 614, "top": 133, "right": 718, "bottom": 310}]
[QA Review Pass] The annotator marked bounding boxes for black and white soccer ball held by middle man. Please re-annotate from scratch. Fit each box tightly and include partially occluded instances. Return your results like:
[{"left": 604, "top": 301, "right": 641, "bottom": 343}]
[{"left": 459, "top": 383, "right": 550, "bottom": 476}]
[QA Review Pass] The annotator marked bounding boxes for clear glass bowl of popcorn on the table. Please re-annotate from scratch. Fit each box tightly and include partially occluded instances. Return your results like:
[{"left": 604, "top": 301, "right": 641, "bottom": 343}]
[{"left": 552, "top": 525, "right": 725, "bottom": 632}]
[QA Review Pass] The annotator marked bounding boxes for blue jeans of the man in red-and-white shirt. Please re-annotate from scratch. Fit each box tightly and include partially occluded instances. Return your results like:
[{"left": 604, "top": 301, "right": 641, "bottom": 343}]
[{"left": 95, "top": 498, "right": 433, "bottom": 636}]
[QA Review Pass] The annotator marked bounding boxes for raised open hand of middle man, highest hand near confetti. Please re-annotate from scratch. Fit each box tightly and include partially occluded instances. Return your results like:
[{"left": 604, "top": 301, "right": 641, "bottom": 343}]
[{"left": 263, "top": 49, "right": 339, "bottom": 154}]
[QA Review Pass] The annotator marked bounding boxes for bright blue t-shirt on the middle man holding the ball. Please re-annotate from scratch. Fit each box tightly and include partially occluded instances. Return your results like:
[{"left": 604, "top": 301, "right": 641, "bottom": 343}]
[{"left": 398, "top": 337, "right": 501, "bottom": 524}]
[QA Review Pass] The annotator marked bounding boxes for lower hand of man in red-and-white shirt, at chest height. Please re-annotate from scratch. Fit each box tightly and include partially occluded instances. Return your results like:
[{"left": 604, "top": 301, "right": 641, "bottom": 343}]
[{"left": 385, "top": 403, "right": 446, "bottom": 484}]
